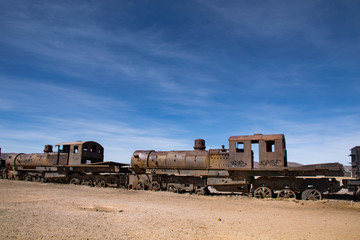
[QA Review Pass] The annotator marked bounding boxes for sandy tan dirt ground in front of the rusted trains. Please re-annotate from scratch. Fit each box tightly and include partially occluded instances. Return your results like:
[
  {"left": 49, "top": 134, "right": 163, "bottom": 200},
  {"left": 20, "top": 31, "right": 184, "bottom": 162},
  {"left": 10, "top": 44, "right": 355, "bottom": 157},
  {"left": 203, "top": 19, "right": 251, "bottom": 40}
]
[{"left": 0, "top": 180, "right": 360, "bottom": 239}]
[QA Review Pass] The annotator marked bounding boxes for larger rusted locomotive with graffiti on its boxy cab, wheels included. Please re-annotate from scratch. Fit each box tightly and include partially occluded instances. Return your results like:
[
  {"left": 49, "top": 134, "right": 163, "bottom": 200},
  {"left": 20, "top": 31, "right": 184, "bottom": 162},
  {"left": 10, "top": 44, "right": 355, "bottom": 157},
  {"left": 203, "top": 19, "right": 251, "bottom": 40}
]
[{"left": 129, "top": 134, "right": 345, "bottom": 199}]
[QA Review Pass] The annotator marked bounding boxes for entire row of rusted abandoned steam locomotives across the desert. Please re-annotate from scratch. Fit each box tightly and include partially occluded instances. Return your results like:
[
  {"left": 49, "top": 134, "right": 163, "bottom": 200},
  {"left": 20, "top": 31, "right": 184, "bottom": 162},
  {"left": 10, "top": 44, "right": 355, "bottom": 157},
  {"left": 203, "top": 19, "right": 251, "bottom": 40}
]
[{"left": 5, "top": 134, "right": 360, "bottom": 200}]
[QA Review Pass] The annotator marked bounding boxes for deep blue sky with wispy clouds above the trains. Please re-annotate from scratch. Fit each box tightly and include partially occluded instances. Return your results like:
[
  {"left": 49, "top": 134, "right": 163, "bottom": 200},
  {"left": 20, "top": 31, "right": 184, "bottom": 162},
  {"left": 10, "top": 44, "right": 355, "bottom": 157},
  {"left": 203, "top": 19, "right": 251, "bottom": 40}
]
[{"left": 0, "top": 0, "right": 360, "bottom": 164}]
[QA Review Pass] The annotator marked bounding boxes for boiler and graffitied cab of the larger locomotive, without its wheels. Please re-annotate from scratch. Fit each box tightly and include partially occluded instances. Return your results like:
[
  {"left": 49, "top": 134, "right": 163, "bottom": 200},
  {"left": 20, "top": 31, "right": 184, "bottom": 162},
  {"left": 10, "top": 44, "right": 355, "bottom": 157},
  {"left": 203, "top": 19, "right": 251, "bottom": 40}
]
[{"left": 131, "top": 134, "right": 287, "bottom": 173}]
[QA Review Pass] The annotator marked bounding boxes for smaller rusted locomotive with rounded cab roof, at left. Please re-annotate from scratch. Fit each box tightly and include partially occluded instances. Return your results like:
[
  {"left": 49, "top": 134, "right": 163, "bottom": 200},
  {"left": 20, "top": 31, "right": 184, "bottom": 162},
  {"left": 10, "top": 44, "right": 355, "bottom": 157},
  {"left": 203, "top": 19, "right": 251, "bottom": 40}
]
[{"left": 4, "top": 141, "right": 130, "bottom": 187}]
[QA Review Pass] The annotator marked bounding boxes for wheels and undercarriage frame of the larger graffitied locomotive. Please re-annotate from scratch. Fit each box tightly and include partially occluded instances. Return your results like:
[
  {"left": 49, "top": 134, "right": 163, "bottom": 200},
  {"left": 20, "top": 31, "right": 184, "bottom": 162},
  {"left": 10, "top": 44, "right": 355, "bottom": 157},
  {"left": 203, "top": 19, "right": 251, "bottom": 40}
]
[{"left": 129, "top": 169, "right": 343, "bottom": 200}]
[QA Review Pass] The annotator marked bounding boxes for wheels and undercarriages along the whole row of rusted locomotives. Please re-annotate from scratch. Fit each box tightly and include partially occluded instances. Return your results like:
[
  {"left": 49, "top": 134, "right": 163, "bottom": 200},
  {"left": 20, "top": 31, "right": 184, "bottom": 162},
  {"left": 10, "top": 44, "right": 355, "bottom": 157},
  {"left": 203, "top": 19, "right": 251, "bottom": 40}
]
[{"left": 1, "top": 166, "right": 360, "bottom": 200}]
